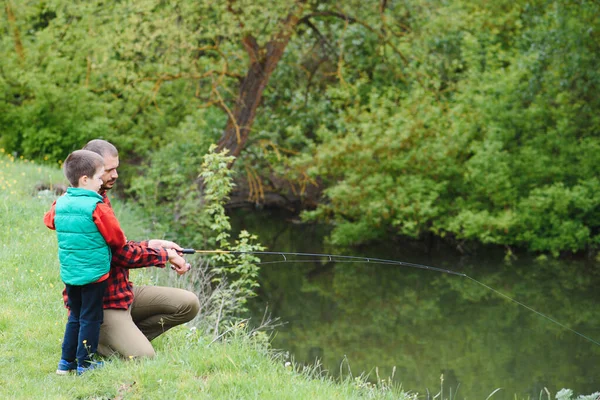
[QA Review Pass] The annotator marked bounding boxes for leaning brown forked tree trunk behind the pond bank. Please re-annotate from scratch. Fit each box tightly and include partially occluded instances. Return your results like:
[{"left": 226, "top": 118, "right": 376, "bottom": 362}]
[{"left": 218, "top": 7, "right": 302, "bottom": 161}]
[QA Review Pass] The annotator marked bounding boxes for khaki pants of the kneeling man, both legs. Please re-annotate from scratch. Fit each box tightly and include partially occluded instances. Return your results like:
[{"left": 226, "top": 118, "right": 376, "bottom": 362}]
[{"left": 98, "top": 286, "right": 200, "bottom": 358}]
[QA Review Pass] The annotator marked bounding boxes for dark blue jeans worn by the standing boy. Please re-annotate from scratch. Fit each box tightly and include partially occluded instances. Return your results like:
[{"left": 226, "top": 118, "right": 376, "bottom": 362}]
[{"left": 62, "top": 280, "right": 108, "bottom": 367}]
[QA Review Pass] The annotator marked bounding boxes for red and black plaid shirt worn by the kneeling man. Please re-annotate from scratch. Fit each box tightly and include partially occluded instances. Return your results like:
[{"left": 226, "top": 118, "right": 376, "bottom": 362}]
[{"left": 57, "top": 193, "right": 169, "bottom": 310}]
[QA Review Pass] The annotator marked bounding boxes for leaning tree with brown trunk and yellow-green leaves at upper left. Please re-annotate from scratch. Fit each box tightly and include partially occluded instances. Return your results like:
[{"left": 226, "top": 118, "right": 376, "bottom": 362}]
[{"left": 4, "top": 0, "right": 408, "bottom": 163}]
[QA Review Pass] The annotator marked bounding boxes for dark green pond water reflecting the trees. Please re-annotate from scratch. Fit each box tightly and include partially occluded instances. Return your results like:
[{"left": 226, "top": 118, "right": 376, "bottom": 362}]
[{"left": 232, "top": 210, "right": 600, "bottom": 399}]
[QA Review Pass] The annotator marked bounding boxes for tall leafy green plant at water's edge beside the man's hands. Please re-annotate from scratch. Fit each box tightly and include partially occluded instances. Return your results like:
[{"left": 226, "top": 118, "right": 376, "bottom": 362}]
[{"left": 145, "top": 145, "right": 264, "bottom": 337}]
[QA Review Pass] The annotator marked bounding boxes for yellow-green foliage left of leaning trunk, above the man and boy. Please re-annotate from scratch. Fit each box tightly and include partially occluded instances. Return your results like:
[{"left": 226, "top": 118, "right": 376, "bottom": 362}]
[{"left": 0, "top": 0, "right": 293, "bottom": 166}]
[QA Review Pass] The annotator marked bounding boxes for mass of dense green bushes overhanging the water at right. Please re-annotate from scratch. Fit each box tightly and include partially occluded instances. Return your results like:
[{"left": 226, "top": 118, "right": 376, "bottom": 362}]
[{"left": 282, "top": 1, "right": 600, "bottom": 255}]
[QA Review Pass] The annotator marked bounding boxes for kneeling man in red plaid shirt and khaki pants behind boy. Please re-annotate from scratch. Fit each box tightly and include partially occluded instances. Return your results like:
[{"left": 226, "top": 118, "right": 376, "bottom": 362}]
[{"left": 74, "top": 139, "right": 200, "bottom": 358}]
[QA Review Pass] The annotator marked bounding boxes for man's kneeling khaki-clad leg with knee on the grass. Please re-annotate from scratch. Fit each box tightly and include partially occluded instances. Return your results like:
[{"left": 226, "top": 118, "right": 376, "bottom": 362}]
[{"left": 98, "top": 309, "right": 156, "bottom": 358}]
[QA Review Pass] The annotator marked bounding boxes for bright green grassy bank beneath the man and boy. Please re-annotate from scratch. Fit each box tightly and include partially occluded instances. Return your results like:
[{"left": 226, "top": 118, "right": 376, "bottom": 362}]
[{"left": 0, "top": 149, "right": 413, "bottom": 399}]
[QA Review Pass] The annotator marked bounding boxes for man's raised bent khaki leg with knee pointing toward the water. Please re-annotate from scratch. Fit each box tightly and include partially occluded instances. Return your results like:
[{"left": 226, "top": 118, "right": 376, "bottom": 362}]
[{"left": 131, "top": 286, "right": 200, "bottom": 340}]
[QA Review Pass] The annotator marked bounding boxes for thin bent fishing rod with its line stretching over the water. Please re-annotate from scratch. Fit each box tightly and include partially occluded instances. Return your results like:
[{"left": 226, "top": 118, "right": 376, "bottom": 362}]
[{"left": 179, "top": 249, "right": 600, "bottom": 346}]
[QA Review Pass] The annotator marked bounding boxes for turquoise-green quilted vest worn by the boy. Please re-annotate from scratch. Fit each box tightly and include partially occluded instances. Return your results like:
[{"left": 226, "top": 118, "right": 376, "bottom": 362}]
[{"left": 54, "top": 187, "right": 111, "bottom": 286}]
